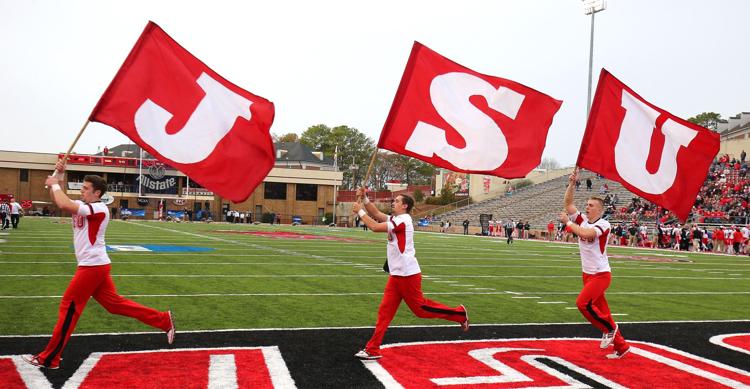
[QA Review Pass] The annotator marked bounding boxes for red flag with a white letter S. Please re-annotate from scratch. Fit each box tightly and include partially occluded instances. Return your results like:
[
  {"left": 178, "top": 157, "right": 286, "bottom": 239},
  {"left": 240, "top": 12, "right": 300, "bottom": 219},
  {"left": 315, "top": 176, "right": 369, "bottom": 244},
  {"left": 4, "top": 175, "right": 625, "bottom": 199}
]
[{"left": 378, "top": 42, "right": 562, "bottom": 178}]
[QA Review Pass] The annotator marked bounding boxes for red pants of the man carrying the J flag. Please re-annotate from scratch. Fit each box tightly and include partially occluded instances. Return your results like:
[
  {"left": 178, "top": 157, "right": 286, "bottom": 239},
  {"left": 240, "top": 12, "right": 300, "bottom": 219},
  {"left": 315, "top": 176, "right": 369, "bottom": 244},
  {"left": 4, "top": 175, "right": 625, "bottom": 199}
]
[{"left": 38, "top": 265, "right": 171, "bottom": 366}]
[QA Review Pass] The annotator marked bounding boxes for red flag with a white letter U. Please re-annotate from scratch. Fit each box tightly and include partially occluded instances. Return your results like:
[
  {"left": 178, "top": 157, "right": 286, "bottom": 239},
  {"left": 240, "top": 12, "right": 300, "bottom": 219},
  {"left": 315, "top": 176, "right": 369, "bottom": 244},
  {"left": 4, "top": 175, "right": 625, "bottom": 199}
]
[{"left": 577, "top": 69, "right": 719, "bottom": 220}]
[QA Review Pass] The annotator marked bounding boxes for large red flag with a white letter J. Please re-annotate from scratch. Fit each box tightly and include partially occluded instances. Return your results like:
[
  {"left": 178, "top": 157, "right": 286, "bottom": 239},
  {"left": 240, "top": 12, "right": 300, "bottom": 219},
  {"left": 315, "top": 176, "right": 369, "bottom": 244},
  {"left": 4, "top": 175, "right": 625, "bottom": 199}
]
[{"left": 89, "top": 22, "right": 275, "bottom": 202}]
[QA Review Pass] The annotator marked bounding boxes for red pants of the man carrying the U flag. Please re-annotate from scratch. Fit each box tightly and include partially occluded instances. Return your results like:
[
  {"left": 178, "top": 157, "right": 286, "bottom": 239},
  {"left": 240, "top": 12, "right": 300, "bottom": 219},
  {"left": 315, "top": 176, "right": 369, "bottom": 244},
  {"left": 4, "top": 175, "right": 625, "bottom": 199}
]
[{"left": 576, "top": 272, "right": 628, "bottom": 351}]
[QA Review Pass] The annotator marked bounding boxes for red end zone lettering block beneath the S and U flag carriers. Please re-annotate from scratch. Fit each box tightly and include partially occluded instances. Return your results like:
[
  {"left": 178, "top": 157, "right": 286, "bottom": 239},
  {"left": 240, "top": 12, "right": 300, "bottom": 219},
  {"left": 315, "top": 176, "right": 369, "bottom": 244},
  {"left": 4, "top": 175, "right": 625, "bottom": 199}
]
[{"left": 364, "top": 338, "right": 750, "bottom": 388}]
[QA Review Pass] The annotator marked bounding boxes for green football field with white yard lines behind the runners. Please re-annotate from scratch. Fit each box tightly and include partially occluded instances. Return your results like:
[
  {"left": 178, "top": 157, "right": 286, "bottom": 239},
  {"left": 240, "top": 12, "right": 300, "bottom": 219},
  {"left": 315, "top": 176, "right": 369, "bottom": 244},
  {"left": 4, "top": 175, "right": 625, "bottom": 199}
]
[{"left": 0, "top": 217, "right": 750, "bottom": 335}]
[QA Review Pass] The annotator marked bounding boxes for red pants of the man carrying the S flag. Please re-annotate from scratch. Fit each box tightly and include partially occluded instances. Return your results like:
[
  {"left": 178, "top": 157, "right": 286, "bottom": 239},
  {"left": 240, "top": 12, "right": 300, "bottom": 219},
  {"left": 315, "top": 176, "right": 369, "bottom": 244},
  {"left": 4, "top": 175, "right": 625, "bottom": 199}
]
[{"left": 366, "top": 273, "right": 466, "bottom": 351}]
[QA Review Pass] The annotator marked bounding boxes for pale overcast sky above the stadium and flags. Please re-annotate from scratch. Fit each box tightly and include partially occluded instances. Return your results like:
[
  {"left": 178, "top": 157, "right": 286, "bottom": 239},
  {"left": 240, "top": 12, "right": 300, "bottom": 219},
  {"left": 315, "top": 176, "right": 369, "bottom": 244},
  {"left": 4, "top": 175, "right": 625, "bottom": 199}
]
[{"left": 0, "top": 0, "right": 750, "bottom": 165}]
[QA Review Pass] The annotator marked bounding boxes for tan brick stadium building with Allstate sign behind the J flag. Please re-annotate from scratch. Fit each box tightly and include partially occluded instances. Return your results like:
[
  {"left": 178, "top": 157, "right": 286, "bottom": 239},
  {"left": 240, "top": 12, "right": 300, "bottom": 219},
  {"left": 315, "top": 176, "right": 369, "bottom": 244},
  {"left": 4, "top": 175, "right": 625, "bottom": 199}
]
[{"left": 0, "top": 142, "right": 343, "bottom": 224}]
